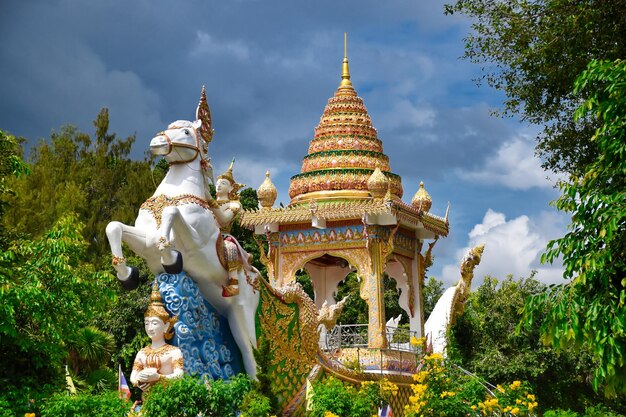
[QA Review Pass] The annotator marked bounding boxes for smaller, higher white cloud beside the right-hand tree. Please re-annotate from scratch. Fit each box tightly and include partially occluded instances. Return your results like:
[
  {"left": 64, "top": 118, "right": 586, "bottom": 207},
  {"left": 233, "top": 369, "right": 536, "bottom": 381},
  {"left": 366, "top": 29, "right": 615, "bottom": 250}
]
[{"left": 459, "top": 135, "right": 556, "bottom": 190}]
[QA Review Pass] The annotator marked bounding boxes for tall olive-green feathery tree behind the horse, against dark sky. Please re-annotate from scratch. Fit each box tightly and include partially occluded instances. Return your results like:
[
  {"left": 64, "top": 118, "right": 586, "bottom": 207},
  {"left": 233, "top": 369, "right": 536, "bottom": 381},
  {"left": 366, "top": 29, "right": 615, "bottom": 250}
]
[{"left": 4, "top": 108, "right": 155, "bottom": 265}]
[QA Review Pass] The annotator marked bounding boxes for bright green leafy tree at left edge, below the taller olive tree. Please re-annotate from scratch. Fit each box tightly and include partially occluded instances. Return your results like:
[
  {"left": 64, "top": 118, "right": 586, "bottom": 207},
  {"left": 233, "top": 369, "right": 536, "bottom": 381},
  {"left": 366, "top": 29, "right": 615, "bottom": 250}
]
[{"left": 0, "top": 216, "right": 113, "bottom": 410}]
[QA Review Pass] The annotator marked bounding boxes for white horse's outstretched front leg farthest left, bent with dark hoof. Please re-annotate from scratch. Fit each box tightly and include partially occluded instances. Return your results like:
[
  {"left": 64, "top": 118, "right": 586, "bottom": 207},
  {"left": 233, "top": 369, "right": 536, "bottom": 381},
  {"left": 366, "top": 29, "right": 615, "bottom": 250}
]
[{"left": 106, "top": 222, "right": 146, "bottom": 290}]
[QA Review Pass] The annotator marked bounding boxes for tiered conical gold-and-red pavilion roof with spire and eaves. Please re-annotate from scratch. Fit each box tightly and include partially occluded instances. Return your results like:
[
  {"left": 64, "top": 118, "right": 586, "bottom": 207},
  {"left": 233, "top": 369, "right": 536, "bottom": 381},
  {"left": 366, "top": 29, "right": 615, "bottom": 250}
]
[{"left": 240, "top": 37, "right": 448, "bottom": 236}]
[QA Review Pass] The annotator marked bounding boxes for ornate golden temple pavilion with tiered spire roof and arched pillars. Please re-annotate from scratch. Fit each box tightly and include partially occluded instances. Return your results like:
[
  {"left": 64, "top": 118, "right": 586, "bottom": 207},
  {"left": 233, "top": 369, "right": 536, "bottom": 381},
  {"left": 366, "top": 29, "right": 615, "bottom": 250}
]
[{"left": 241, "top": 36, "right": 449, "bottom": 349}]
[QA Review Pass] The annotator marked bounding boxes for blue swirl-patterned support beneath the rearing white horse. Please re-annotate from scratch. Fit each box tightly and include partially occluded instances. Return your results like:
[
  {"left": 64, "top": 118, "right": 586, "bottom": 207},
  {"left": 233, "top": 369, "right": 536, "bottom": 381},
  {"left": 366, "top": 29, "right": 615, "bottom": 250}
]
[{"left": 157, "top": 271, "right": 243, "bottom": 380}]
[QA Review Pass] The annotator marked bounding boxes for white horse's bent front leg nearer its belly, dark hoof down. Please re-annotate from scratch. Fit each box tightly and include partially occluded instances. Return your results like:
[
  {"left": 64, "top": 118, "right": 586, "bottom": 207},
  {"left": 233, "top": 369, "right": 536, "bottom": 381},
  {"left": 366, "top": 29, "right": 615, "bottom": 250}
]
[{"left": 158, "top": 206, "right": 202, "bottom": 274}]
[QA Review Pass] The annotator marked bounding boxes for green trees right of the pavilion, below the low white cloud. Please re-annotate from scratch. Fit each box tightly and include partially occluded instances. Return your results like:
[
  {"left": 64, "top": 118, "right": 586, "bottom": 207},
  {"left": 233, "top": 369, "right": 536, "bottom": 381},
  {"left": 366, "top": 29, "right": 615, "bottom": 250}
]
[{"left": 450, "top": 277, "right": 612, "bottom": 410}]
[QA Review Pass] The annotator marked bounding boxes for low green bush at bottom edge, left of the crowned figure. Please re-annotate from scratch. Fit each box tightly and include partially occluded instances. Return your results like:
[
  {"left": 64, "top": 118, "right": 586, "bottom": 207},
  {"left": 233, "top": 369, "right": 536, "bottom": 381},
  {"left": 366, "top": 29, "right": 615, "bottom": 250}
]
[{"left": 41, "top": 391, "right": 131, "bottom": 417}]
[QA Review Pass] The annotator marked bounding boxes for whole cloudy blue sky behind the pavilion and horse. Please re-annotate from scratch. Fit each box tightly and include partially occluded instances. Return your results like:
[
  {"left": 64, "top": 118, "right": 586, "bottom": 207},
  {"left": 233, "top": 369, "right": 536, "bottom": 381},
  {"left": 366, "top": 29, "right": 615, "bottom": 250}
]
[{"left": 0, "top": 0, "right": 567, "bottom": 284}]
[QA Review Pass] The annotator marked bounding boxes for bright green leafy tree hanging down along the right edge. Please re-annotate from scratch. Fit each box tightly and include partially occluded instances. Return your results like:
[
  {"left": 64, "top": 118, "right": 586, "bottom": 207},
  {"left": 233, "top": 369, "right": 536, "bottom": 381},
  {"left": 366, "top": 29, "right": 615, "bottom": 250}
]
[{"left": 525, "top": 60, "right": 626, "bottom": 395}]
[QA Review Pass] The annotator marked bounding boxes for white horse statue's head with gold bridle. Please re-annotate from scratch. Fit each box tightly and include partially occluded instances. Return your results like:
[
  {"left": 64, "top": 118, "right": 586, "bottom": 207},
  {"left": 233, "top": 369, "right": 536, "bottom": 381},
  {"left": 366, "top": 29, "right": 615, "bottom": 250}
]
[{"left": 150, "top": 120, "right": 206, "bottom": 164}]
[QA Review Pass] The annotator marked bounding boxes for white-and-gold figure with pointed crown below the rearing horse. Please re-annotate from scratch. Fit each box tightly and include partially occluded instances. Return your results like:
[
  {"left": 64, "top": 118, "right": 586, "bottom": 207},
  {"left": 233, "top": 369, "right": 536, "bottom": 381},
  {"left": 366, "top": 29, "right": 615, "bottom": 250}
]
[{"left": 130, "top": 282, "right": 183, "bottom": 392}]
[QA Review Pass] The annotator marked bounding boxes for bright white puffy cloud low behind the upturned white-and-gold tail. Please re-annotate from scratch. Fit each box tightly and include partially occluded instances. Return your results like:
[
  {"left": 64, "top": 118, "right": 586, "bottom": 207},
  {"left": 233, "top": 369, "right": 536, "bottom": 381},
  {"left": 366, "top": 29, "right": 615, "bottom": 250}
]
[{"left": 442, "top": 209, "right": 564, "bottom": 287}]
